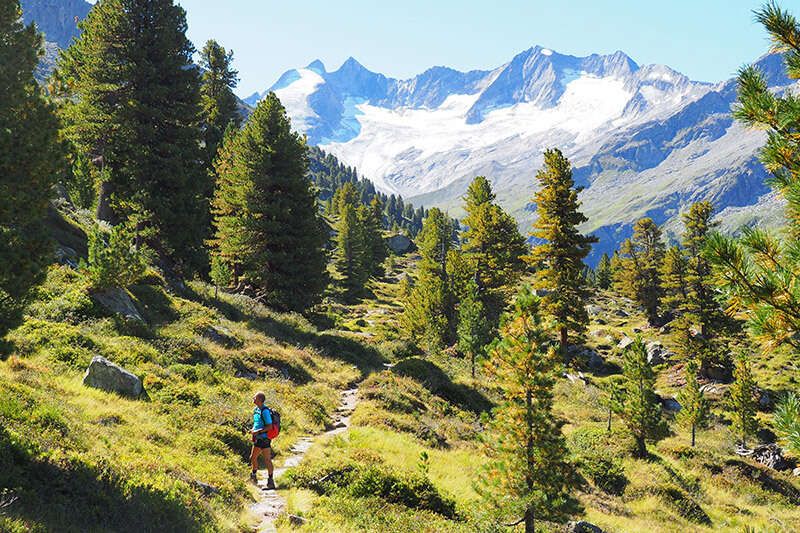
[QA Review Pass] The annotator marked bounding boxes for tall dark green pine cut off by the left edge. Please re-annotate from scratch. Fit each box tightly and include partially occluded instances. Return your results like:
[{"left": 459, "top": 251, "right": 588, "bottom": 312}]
[{"left": 0, "top": 1, "right": 66, "bottom": 352}]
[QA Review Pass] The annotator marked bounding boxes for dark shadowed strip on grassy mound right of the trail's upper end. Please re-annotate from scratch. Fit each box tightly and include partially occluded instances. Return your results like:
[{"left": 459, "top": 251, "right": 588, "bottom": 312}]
[{"left": 392, "top": 357, "right": 492, "bottom": 414}]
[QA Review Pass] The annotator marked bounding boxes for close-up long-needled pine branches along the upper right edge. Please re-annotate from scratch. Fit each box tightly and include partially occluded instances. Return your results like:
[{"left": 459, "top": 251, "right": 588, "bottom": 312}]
[{"left": 708, "top": 3, "right": 800, "bottom": 356}]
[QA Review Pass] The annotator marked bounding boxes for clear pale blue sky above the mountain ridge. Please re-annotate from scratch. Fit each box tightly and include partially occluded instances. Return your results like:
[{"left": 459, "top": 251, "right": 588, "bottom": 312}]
[{"left": 179, "top": 0, "right": 788, "bottom": 96}]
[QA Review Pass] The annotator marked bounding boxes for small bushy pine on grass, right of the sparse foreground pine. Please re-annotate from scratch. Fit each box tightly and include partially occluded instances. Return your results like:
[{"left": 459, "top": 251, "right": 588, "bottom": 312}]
[{"left": 620, "top": 338, "right": 662, "bottom": 459}]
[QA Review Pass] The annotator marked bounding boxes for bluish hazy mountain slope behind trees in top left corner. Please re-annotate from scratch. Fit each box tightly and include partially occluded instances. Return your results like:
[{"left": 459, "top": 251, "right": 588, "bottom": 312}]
[{"left": 20, "top": 0, "right": 92, "bottom": 48}]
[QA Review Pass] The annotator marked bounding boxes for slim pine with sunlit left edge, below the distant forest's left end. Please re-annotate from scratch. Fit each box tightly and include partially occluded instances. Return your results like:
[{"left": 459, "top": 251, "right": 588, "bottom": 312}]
[{"left": 334, "top": 204, "right": 369, "bottom": 299}]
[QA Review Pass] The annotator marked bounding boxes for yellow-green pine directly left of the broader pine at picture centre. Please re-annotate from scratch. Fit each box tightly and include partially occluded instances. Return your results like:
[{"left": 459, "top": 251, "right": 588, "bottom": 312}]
[{"left": 403, "top": 208, "right": 455, "bottom": 352}]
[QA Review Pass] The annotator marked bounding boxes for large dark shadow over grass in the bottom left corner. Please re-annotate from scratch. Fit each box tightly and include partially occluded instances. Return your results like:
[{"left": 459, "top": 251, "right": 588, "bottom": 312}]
[{"left": 0, "top": 428, "right": 211, "bottom": 532}]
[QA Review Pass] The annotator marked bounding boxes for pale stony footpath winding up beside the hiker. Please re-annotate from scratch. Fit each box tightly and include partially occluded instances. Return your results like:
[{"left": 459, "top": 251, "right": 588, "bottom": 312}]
[{"left": 250, "top": 388, "right": 358, "bottom": 533}]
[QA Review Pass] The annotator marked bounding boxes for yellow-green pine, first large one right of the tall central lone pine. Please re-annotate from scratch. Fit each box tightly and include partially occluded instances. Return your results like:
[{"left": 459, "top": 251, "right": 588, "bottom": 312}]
[{"left": 615, "top": 218, "right": 664, "bottom": 325}]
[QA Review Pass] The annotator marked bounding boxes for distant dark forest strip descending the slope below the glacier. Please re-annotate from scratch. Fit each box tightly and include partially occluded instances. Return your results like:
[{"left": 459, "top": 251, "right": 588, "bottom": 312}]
[{"left": 308, "top": 146, "right": 428, "bottom": 238}]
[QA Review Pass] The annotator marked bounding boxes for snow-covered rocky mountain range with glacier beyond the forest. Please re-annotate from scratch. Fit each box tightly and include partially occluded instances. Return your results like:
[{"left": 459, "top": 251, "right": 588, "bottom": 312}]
[{"left": 253, "top": 46, "right": 792, "bottom": 257}]
